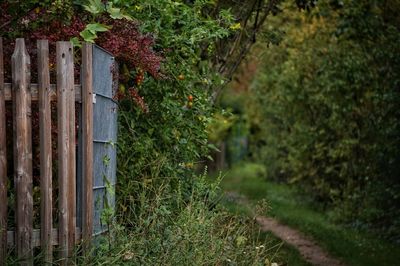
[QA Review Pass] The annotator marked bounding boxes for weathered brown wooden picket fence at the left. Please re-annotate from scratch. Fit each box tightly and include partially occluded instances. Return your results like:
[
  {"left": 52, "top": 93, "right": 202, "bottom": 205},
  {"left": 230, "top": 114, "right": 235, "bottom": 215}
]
[{"left": 0, "top": 38, "right": 94, "bottom": 265}]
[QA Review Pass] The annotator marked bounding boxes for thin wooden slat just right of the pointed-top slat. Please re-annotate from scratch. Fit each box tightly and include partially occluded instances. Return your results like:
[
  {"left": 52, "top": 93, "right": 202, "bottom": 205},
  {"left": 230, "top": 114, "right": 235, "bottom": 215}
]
[{"left": 37, "top": 40, "right": 53, "bottom": 263}]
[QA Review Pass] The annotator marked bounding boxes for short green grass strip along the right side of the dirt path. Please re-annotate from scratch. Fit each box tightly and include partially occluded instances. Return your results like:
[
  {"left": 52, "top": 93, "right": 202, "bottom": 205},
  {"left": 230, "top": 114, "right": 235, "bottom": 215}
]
[{"left": 214, "top": 163, "right": 400, "bottom": 266}]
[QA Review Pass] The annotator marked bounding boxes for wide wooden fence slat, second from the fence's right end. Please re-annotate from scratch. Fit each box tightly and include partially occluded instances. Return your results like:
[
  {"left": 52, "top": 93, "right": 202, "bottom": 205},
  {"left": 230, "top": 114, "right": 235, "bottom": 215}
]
[{"left": 56, "top": 42, "right": 75, "bottom": 265}]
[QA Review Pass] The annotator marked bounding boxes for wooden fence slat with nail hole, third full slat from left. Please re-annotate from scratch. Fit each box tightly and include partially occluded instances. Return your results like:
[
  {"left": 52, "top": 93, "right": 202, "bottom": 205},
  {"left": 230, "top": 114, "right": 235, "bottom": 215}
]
[{"left": 56, "top": 42, "right": 73, "bottom": 265}]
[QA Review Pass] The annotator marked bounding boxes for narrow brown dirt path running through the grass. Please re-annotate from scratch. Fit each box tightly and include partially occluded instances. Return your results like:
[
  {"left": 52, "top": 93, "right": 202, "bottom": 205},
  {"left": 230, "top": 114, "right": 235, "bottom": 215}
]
[{"left": 226, "top": 192, "right": 345, "bottom": 266}]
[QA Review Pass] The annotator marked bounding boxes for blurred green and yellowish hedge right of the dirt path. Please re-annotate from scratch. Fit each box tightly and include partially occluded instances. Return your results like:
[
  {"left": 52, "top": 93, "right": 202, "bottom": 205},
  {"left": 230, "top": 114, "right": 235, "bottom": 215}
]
[{"left": 252, "top": 0, "right": 400, "bottom": 236}]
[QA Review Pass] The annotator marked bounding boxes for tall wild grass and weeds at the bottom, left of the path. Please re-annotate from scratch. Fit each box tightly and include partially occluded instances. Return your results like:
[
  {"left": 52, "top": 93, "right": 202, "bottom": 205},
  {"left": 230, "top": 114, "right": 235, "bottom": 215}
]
[{"left": 8, "top": 176, "right": 275, "bottom": 266}]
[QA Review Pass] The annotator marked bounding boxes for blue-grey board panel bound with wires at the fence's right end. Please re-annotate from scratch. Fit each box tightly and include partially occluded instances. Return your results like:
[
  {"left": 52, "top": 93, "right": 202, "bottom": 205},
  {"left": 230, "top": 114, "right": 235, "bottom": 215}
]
[{"left": 93, "top": 46, "right": 118, "bottom": 235}]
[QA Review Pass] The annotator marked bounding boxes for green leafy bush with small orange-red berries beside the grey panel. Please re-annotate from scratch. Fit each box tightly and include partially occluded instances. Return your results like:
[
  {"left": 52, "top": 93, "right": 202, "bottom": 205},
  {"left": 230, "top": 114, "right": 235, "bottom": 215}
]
[{"left": 112, "top": 1, "right": 233, "bottom": 222}]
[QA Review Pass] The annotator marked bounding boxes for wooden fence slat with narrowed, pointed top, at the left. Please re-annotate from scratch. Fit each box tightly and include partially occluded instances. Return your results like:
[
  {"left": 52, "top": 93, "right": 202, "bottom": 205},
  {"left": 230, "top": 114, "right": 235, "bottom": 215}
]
[{"left": 12, "top": 38, "right": 33, "bottom": 265}]
